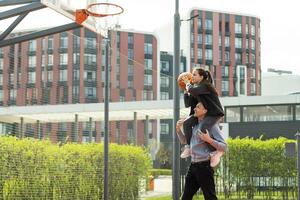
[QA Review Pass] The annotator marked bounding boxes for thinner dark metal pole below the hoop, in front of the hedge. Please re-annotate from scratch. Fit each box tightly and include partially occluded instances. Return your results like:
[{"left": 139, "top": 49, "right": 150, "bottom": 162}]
[{"left": 104, "top": 35, "right": 110, "bottom": 200}]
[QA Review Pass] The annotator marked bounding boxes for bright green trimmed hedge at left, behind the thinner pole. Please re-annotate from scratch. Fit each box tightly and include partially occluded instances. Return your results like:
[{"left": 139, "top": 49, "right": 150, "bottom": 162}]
[{"left": 0, "top": 137, "right": 151, "bottom": 200}]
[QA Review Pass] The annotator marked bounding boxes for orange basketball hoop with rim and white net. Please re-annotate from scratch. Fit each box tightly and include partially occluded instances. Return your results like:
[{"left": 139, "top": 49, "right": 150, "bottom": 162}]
[{"left": 75, "top": 3, "right": 124, "bottom": 37}]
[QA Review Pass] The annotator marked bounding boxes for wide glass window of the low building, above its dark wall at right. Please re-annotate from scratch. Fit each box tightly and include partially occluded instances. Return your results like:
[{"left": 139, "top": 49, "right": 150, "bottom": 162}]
[{"left": 243, "top": 105, "right": 293, "bottom": 122}]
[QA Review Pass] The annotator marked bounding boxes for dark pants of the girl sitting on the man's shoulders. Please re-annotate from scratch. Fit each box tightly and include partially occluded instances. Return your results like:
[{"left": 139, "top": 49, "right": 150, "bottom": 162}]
[{"left": 183, "top": 115, "right": 221, "bottom": 145}]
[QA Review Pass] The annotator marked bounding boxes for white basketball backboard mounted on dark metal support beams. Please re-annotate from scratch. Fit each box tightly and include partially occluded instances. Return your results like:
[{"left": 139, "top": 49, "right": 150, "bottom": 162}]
[{"left": 41, "top": 0, "right": 122, "bottom": 35}]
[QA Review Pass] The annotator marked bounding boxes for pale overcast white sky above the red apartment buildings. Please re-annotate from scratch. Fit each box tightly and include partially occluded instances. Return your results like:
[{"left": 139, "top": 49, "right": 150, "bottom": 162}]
[{"left": 0, "top": 0, "right": 300, "bottom": 75}]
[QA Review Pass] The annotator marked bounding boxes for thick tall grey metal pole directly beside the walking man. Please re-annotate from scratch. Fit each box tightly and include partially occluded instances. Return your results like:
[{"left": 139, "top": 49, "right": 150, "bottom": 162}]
[{"left": 172, "top": 0, "right": 180, "bottom": 200}]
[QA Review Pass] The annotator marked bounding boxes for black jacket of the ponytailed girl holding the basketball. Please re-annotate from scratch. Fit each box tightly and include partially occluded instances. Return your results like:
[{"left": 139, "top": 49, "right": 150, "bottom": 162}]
[{"left": 184, "top": 84, "right": 224, "bottom": 117}]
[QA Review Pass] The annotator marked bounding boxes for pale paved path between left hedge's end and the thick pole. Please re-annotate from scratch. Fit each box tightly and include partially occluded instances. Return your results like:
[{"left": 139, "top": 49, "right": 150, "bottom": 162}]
[{"left": 141, "top": 176, "right": 172, "bottom": 199}]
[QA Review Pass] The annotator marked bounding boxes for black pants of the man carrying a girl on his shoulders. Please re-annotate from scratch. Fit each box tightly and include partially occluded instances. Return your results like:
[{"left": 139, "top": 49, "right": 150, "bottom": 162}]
[{"left": 181, "top": 161, "right": 218, "bottom": 200}]
